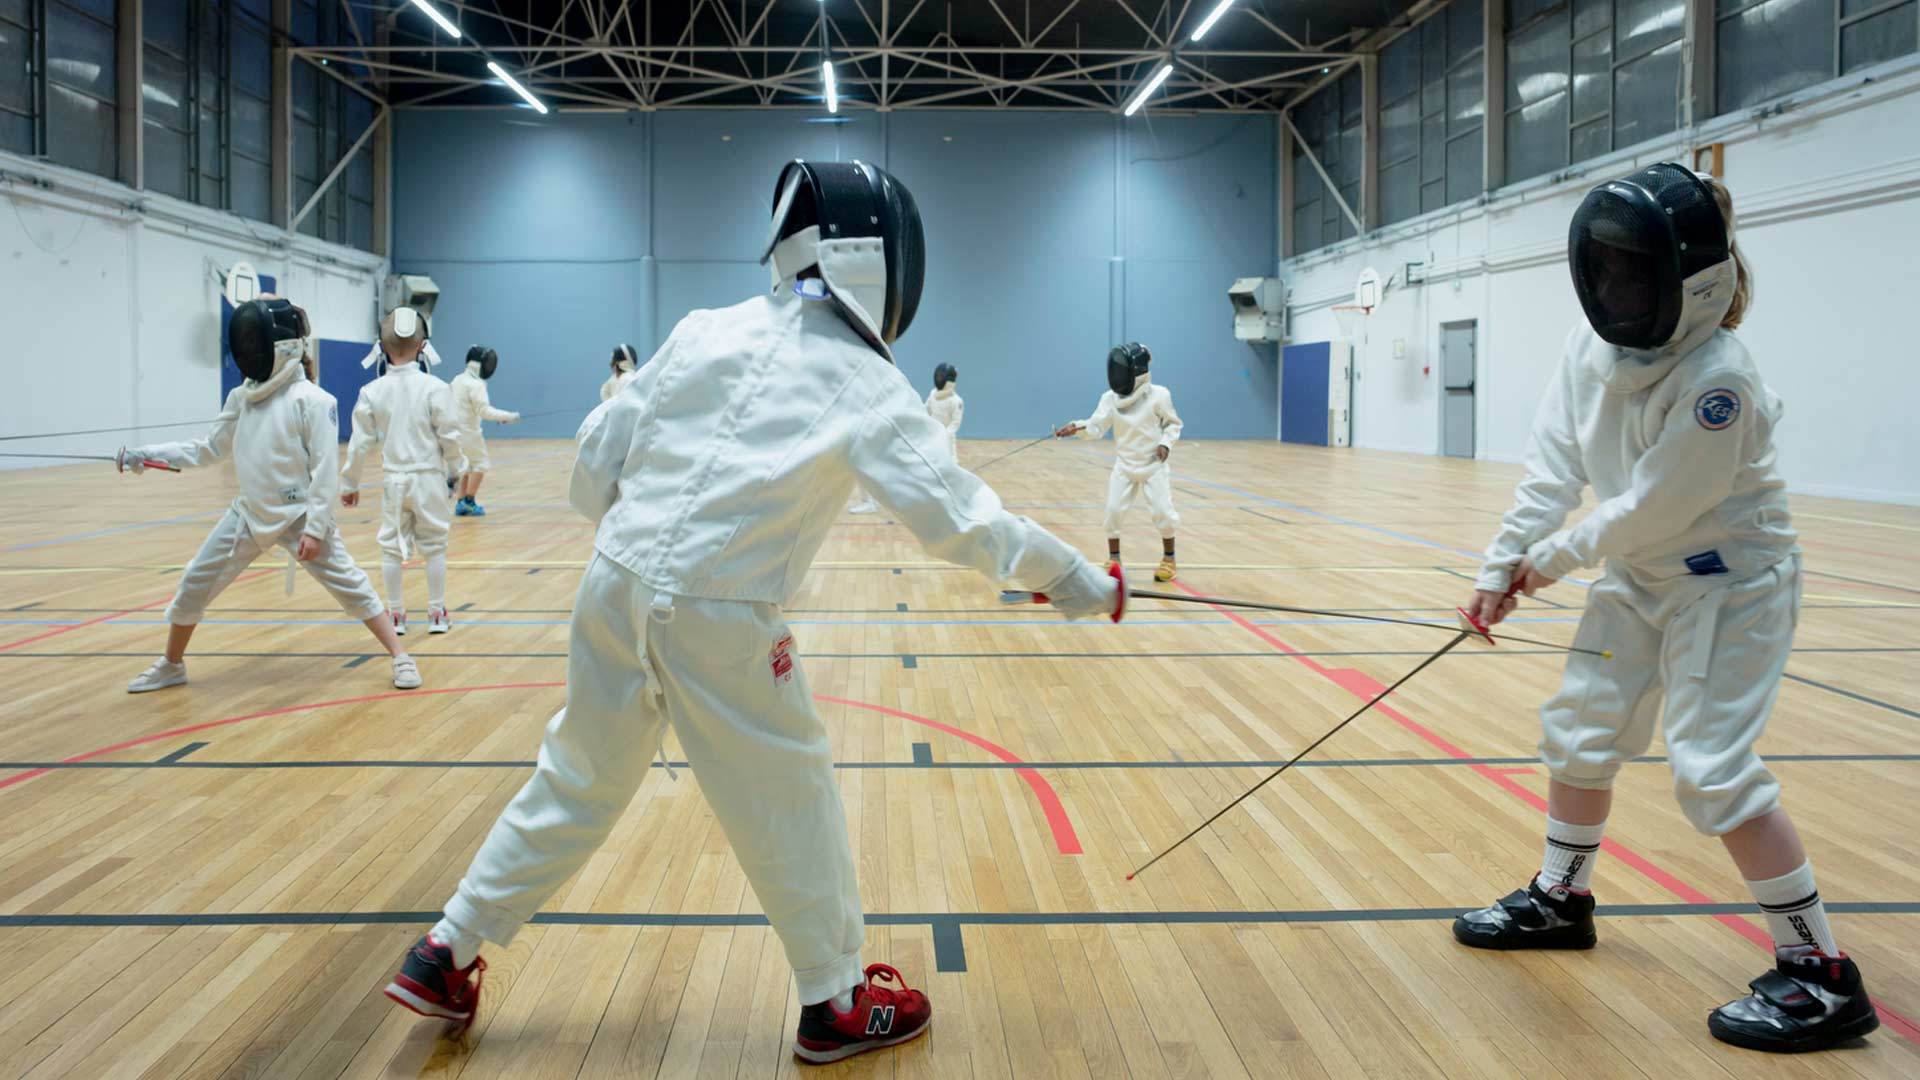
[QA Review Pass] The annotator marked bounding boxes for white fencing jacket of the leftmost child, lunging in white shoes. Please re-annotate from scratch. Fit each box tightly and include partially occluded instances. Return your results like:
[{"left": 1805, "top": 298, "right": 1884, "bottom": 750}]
[{"left": 129, "top": 361, "right": 340, "bottom": 548}]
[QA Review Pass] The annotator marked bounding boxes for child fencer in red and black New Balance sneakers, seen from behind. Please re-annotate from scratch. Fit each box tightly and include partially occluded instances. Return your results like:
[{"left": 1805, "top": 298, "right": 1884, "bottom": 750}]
[{"left": 386, "top": 161, "right": 1125, "bottom": 1063}]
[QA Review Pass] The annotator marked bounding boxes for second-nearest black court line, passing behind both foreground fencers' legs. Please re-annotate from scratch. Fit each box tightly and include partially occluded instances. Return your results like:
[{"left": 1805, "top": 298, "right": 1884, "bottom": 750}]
[{"left": 0, "top": 742, "right": 1920, "bottom": 773}]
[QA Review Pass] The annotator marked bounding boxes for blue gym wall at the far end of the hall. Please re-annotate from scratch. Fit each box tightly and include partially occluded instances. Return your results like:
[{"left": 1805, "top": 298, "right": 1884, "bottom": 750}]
[{"left": 394, "top": 110, "right": 1277, "bottom": 438}]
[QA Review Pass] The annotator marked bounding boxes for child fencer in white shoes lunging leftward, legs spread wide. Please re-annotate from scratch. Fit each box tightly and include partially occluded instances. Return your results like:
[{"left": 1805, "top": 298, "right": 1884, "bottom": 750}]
[{"left": 123, "top": 296, "right": 420, "bottom": 694}]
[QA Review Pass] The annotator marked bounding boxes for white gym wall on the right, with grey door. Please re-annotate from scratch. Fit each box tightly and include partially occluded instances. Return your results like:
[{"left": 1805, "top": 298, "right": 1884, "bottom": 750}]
[{"left": 1283, "top": 60, "right": 1920, "bottom": 503}]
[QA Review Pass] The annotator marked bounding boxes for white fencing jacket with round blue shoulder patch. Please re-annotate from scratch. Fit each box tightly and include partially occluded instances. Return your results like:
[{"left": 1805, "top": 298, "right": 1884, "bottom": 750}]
[{"left": 1476, "top": 304, "right": 1797, "bottom": 592}]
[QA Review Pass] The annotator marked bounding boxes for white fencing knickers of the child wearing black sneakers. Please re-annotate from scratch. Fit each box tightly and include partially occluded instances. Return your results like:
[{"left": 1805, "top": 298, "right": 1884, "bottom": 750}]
[{"left": 1540, "top": 555, "right": 1801, "bottom": 836}]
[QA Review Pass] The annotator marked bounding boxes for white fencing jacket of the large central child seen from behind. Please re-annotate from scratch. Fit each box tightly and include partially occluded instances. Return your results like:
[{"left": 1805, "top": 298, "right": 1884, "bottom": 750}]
[{"left": 570, "top": 279, "right": 1083, "bottom": 603}]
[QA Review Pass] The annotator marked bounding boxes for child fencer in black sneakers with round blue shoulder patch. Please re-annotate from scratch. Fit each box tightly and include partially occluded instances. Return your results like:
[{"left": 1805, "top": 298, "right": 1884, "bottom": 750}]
[{"left": 1453, "top": 163, "right": 1880, "bottom": 1051}]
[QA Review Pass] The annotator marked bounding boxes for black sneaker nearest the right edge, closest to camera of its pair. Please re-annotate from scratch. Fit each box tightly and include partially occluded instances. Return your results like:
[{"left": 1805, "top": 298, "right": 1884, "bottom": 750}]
[{"left": 1707, "top": 949, "right": 1880, "bottom": 1053}]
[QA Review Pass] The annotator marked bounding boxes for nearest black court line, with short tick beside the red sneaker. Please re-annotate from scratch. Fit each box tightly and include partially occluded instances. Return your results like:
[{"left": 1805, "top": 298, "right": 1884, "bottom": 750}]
[{"left": 0, "top": 901, "right": 1920, "bottom": 972}]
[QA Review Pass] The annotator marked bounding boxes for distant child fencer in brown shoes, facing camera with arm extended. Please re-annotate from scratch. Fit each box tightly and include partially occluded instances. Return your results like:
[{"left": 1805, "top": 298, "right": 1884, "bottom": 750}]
[{"left": 1054, "top": 342, "right": 1181, "bottom": 580}]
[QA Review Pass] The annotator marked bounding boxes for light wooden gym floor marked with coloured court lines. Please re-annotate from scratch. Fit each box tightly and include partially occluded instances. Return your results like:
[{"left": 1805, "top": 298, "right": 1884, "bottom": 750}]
[{"left": 0, "top": 438, "right": 1920, "bottom": 1080}]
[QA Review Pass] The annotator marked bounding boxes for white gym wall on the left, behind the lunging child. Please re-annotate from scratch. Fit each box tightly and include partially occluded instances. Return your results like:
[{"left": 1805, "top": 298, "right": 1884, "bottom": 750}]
[{"left": 0, "top": 154, "right": 386, "bottom": 467}]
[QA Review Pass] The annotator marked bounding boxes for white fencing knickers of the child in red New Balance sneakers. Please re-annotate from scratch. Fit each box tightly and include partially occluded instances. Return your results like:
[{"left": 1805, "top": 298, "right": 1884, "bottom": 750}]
[{"left": 445, "top": 553, "right": 866, "bottom": 1003}]
